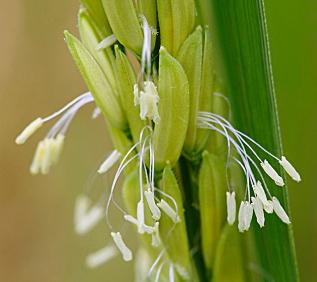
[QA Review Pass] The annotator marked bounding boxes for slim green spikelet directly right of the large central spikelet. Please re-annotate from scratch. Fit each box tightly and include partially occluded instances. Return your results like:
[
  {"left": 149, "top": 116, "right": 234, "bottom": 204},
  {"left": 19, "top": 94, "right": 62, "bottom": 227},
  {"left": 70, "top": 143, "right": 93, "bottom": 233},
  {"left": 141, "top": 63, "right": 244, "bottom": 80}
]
[{"left": 177, "top": 26, "right": 203, "bottom": 154}]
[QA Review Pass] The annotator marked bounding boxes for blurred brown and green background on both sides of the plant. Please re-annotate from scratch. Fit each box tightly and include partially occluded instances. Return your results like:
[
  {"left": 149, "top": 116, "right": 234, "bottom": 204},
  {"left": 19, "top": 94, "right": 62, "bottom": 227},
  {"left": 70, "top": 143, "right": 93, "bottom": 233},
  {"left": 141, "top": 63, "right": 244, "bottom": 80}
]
[{"left": 0, "top": 0, "right": 317, "bottom": 282}]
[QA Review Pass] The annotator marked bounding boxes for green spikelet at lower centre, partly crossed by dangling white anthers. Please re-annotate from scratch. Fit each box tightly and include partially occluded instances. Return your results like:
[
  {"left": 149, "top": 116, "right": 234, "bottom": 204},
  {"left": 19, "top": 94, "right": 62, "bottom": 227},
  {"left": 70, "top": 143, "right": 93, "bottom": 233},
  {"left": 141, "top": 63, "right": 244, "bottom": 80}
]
[{"left": 160, "top": 163, "right": 192, "bottom": 280}]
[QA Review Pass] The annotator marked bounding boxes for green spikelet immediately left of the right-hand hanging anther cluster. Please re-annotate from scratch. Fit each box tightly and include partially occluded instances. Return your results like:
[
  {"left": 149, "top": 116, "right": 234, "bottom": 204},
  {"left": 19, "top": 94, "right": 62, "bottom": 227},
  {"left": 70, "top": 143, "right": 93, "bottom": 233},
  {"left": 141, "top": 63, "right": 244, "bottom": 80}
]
[{"left": 198, "top": 151, "right": 227, "bottom": 269}]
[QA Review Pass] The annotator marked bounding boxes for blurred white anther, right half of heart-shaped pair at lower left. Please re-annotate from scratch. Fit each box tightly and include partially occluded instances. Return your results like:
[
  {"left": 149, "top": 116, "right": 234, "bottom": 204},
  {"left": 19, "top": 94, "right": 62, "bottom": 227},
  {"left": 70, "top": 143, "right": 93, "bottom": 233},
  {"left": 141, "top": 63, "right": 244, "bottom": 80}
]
[{"left": 75, "top": 205, "right": 105, "bottom": 235}]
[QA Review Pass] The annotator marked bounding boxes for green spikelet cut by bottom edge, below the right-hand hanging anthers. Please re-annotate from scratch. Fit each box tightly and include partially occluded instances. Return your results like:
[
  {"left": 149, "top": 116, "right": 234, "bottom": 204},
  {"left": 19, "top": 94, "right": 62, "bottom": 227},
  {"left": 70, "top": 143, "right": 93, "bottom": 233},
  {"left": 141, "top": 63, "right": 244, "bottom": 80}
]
[{"left": 212, "top": 224, "right": 244, "bottom": 282}]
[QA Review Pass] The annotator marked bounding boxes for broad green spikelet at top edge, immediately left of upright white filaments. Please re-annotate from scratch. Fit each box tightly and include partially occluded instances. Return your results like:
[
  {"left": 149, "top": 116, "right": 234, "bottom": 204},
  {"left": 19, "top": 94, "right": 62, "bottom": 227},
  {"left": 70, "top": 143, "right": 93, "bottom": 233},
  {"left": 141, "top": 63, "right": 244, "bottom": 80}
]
[{"left": 102, "top": 0, "right": 143, "bottom": 55}]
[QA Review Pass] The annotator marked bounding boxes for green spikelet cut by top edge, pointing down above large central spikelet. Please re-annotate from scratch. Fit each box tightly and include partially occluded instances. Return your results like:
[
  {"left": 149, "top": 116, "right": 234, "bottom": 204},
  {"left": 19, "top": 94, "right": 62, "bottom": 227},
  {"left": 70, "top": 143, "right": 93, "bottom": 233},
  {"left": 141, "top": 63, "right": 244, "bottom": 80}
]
[{"left": 157, "top": 0, "right": 196, "bottom": 57}]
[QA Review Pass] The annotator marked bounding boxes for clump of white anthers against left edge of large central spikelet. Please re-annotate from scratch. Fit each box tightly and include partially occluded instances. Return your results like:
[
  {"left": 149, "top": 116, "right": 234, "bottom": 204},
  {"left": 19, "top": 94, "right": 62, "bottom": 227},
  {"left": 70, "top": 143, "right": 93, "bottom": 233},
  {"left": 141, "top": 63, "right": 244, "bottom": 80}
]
[{"left": 140, "top": 81, "right": 161, "bottom": 123}]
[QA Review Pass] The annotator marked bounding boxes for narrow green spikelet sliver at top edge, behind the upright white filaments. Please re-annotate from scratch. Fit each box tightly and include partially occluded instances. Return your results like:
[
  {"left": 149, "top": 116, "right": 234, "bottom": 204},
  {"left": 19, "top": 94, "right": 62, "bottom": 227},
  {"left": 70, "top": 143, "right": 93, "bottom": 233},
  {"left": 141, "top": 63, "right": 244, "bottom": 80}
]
[{"left": 138, "top": 0, "right": 157, "bottom": 51}]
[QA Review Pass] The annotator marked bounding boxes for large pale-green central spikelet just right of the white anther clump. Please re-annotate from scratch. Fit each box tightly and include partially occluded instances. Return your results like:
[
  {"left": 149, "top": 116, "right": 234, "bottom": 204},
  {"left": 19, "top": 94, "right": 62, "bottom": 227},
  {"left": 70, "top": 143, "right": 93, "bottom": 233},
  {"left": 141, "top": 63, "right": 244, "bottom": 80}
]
[{"left": 153, "top": 47, "right": 189, "bottom": 171}]
